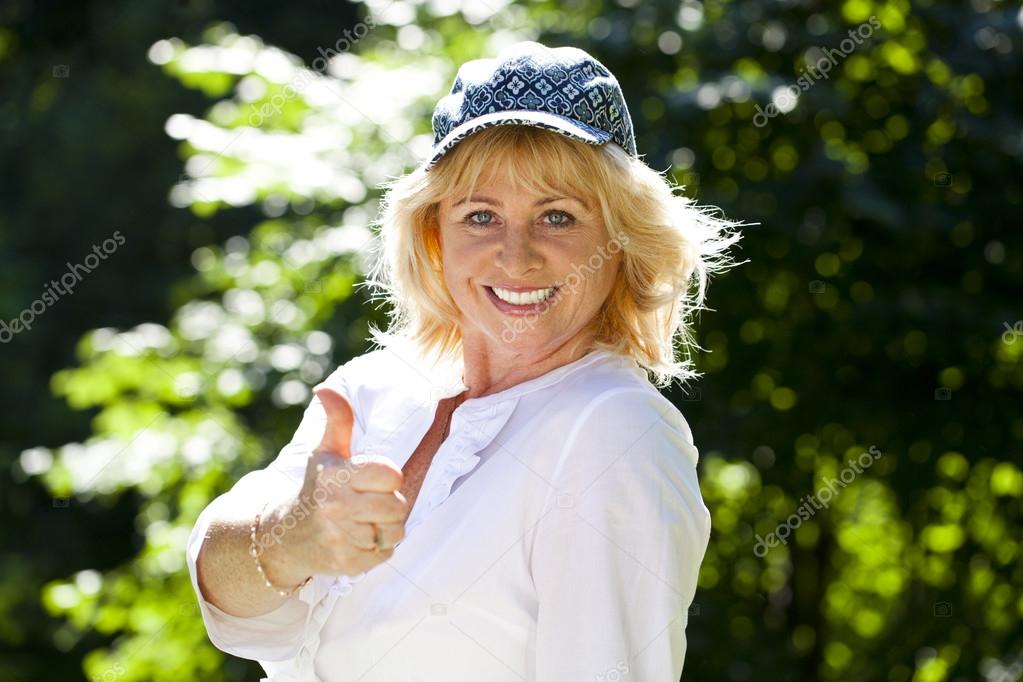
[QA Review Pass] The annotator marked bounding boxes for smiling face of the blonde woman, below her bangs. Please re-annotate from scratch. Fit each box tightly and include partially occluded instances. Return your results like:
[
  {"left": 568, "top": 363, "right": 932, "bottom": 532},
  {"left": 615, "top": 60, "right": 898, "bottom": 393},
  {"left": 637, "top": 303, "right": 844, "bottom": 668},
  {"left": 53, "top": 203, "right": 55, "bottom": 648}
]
[{"left": 439, "top": 174, "right": 622, "bottom": 357}]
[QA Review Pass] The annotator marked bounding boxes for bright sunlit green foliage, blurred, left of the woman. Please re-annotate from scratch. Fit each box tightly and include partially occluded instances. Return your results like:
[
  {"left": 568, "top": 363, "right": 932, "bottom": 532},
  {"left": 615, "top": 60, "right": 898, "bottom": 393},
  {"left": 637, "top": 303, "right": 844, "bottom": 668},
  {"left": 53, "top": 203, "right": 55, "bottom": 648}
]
[{"left": 21, "top": 24, "right": 405, "bottom": 681}]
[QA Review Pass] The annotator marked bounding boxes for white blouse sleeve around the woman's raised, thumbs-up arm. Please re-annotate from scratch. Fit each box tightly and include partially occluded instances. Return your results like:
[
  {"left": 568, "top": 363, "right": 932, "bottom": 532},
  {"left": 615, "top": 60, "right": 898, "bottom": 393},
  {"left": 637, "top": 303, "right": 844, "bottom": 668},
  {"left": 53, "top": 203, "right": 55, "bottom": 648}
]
[{"left": 186, "top": 367, "right": 351, "bottom": 661}]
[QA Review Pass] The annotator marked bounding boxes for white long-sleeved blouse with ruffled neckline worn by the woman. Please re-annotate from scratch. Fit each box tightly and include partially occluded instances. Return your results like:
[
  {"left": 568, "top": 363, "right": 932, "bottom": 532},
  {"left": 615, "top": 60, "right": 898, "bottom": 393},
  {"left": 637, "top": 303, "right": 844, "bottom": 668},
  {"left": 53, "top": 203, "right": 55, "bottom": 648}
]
[{"left": 187, "top": 346, "right": 710, "bottom": 682}]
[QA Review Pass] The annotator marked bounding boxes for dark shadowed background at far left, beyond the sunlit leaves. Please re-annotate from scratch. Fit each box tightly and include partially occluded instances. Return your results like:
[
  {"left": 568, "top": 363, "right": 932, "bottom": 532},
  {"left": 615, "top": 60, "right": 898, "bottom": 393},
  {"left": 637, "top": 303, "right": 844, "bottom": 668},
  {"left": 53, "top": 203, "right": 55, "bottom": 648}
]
[{"left": 0, "top": 0, "right": 357, "bottom": 680}]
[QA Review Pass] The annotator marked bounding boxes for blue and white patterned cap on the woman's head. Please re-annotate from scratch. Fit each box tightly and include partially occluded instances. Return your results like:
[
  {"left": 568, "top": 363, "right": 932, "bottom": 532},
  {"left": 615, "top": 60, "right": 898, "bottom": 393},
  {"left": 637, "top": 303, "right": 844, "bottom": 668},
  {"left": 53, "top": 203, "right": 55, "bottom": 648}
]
[{"left": 426, "top": 41, "right": 636, "bottom": 170}]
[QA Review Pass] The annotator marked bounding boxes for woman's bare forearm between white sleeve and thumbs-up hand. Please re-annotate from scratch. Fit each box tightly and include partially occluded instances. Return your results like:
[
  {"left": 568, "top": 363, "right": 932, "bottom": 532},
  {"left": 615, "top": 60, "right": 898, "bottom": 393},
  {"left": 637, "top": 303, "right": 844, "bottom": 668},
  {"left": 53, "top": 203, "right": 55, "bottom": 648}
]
[{"left": 195, "top": 502, "right": 308, "bottom": 618}]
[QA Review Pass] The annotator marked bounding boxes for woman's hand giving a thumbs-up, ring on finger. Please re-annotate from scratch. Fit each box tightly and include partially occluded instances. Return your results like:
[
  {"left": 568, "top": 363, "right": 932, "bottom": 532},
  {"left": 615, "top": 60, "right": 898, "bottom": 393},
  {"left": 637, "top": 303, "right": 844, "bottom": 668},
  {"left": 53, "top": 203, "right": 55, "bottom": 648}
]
[{"left": 264, "top": 385, "right": 409, "bottom": 577}]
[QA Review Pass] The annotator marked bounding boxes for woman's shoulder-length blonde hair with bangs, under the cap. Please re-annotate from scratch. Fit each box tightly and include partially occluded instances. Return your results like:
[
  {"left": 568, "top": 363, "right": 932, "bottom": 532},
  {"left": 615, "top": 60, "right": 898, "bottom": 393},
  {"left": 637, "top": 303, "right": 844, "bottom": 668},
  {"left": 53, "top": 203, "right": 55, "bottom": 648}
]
[{"left": 365, "top": 125, "right": 742, "bottom": 388}]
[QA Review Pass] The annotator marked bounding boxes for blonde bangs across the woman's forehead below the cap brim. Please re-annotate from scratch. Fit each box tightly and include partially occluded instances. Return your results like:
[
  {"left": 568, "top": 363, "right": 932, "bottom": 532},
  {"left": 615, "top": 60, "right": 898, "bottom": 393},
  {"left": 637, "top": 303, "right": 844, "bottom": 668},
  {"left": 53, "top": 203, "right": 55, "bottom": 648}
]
[{"left": 432, "top": 125, "right": 603, "bottom": 215}]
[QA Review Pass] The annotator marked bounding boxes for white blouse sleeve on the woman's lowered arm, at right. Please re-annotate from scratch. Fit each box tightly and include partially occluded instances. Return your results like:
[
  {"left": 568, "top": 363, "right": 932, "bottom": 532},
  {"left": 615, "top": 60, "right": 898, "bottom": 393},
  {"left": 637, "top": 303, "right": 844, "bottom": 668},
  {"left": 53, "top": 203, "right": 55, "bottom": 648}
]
[{"left": 531, "top": 389, "right": 710, "bottom": 682}]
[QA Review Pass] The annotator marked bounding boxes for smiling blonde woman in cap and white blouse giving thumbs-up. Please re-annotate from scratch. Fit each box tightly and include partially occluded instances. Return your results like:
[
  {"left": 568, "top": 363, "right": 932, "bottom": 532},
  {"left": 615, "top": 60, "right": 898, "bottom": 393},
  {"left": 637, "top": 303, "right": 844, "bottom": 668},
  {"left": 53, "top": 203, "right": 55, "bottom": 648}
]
[{"left": 188, "top": 42, "right": 739, "bottom": 682}]
